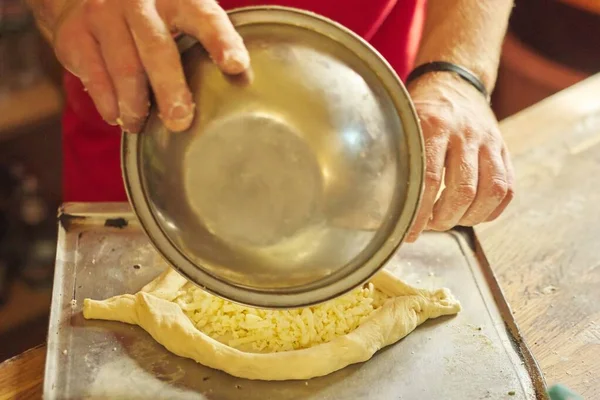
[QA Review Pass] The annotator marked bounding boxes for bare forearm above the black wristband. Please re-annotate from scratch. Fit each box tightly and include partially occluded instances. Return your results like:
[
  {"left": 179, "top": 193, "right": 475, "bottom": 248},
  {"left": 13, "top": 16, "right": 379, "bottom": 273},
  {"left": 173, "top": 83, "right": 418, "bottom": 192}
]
[{"left": 416, "top": 0, "right": 513, "bottom": 92}]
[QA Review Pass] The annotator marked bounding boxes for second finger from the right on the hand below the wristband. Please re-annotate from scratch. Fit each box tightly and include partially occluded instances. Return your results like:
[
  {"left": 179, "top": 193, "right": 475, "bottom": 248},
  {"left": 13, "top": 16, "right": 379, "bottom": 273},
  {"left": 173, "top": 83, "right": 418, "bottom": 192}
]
[{"left": 458, "top": 146, "right": 508, "bottom": 226}]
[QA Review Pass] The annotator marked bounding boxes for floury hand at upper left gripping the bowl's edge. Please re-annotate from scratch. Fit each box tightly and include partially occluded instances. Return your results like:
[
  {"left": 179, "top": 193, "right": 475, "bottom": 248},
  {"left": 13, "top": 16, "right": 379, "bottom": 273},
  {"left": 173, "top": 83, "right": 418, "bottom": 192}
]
[{"left": 50, "top": 0, "right": 250, "bottom": 132}]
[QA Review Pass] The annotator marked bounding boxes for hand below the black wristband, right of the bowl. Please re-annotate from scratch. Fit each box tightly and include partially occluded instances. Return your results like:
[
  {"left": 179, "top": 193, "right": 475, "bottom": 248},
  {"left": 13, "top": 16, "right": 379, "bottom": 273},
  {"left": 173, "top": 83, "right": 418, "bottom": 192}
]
[{"left": 407, "top": 73, "right": 514, "bottom": 242}]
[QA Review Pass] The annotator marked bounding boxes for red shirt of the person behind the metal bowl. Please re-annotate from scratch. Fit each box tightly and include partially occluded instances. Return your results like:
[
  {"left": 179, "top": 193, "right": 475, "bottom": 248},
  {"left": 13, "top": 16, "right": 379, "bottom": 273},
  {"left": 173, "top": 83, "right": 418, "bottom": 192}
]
[{"left": 63, "top": 0, "right": 426, "bottom": 202}]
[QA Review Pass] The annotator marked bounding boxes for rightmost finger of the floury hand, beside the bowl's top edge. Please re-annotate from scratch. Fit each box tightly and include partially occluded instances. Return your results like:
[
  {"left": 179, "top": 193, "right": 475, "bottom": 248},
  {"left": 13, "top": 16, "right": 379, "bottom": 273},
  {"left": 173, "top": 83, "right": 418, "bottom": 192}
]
[{"left": 168, "top": 0, "right": 250, "bottom": 75}]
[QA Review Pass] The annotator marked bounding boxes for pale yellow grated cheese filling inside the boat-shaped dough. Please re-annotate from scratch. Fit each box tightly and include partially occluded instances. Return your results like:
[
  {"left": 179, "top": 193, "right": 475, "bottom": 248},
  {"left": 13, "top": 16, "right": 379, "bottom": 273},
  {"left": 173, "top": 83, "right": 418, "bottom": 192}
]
[{"left": 173, "top": 283, "right": 388, "bottom": 353}]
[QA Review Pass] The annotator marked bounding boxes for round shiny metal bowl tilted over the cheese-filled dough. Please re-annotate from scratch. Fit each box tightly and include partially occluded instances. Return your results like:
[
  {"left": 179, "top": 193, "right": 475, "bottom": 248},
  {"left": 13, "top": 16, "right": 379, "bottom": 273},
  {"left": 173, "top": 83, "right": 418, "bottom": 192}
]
[{"left": 122, "top": 7, "right": 424, "bottom": 308}]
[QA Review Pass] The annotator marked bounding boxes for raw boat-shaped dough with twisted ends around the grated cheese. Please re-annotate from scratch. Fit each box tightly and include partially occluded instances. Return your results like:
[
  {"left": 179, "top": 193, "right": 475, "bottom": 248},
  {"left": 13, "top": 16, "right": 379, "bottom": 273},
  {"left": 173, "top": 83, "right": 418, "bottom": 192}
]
[{"left": 83, "top": 269, "right": 461, "bottom": 380}]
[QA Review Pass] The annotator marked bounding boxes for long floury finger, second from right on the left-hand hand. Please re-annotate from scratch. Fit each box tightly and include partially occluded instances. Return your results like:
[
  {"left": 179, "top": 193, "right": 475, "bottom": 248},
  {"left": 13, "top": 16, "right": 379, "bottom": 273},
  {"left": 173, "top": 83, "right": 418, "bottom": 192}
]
[{"left": 125, "top": 0, "right": 194, "bottom": 131}]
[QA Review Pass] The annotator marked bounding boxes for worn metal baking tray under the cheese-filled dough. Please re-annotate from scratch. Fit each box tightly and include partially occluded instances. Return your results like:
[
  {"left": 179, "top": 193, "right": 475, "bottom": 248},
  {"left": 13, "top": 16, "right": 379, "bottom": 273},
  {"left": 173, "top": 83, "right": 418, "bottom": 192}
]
[{"left": 44, "top": 203, "right": 547, "bottom": 400}]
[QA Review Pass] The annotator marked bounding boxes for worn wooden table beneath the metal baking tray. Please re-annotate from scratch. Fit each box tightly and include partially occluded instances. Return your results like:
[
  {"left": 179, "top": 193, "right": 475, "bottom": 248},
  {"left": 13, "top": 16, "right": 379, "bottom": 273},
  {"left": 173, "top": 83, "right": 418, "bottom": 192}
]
[{"left": 0, "top": 75, "right": 600, "bottom": 399}]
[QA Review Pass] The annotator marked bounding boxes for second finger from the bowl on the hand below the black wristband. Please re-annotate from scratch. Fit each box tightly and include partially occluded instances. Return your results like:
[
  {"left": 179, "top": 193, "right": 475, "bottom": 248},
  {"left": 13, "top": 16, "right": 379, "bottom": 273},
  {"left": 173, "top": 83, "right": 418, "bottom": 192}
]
[{"left": 429, "top": 139, "right": 479, "bottom": 231}]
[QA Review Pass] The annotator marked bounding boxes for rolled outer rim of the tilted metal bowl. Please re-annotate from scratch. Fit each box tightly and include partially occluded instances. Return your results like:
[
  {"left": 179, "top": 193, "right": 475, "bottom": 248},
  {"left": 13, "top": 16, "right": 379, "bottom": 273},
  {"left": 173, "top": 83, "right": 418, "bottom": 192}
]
[{"left": 121, "top": 6, "right": 425, "bottom": 308}]
